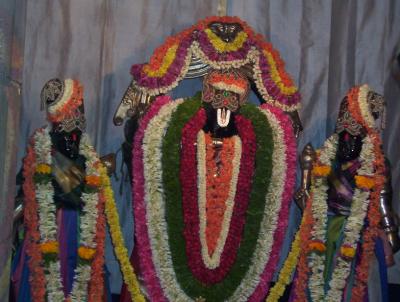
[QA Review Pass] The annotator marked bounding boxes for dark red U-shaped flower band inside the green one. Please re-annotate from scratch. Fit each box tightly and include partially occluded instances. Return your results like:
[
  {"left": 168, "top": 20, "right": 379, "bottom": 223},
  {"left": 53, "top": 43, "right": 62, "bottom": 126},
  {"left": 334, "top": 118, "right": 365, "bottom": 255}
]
[{"left": 180, "top": 109, "right": 256, "bottom": 284}]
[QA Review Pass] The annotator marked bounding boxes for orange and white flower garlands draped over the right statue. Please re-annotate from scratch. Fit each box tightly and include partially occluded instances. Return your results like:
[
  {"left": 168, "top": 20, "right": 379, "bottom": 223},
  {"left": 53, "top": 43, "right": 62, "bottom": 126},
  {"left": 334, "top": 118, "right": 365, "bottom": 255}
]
[{"left": 295, "top": 85, "right": 384, "bottom": 301}]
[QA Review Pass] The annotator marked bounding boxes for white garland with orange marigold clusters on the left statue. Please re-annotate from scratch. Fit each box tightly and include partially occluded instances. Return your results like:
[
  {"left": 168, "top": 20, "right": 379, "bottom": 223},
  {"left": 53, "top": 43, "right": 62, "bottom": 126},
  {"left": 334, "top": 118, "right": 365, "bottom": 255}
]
[{"left": 28, "top": 128, "right": 101, "bottom": 301}]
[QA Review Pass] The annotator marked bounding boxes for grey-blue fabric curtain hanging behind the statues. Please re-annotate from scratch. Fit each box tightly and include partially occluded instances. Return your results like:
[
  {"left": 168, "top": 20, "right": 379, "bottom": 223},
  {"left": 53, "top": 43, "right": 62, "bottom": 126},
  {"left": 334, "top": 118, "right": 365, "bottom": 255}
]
[{"left": 0, "top": 0, "right": 400, "bottom": 298}]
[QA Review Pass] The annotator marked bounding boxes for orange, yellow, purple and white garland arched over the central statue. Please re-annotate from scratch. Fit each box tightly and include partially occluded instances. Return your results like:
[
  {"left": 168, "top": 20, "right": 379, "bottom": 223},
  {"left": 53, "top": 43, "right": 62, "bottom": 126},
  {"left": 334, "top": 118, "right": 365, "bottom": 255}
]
[{"left": 131, "top": 17, "right": 300, "bottom": 111}]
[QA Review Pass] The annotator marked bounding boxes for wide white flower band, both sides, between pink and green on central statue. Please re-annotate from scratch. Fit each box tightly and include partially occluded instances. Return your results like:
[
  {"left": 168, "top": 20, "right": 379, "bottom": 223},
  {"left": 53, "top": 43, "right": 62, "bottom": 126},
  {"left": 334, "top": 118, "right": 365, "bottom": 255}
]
[{"left": 143, "top": 100, "right": 286, "bottom": 301}]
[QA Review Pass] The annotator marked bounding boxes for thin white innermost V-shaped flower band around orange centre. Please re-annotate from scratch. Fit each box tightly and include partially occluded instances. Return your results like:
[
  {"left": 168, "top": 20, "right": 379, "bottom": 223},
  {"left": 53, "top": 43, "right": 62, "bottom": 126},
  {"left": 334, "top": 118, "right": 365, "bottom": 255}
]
[{"left": 197, "top": 130, "right": 242, "bottom": 269}]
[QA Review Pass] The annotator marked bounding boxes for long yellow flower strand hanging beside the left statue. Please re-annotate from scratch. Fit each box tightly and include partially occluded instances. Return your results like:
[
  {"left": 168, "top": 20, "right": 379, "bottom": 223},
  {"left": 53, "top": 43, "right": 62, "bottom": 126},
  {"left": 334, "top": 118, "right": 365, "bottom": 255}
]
[{"left": 100, "top": 166, "right": 146, "bottom": 302}]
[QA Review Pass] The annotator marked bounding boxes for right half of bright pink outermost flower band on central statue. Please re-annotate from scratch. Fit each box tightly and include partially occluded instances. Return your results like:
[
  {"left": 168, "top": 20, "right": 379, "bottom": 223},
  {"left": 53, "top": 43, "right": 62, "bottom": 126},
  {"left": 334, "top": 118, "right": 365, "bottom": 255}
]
[{"left": 249, "top": 104, "right": 297, "bottom": 301}]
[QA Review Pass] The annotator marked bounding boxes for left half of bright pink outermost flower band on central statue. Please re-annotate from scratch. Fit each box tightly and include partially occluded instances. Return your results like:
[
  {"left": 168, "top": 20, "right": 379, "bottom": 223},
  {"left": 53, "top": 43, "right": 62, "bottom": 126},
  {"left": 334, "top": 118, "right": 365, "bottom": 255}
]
[{"left": 131, "top": 96, "right": 171, "bottom": 301}]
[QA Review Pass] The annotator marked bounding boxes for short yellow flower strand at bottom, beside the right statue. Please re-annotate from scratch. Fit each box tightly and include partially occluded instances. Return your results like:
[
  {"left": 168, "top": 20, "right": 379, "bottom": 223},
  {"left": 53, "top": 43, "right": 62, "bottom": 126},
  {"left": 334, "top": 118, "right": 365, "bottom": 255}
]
[{"left": 265, "top": 231, "right": 300, "bottom": 302}]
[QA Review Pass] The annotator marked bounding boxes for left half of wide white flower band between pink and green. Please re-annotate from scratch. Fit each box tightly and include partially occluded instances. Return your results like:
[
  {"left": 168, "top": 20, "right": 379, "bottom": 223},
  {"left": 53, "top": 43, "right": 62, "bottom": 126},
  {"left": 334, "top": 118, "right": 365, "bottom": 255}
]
[{"left": 142, "top": 99, "right": 191, "bottom": 301}]
